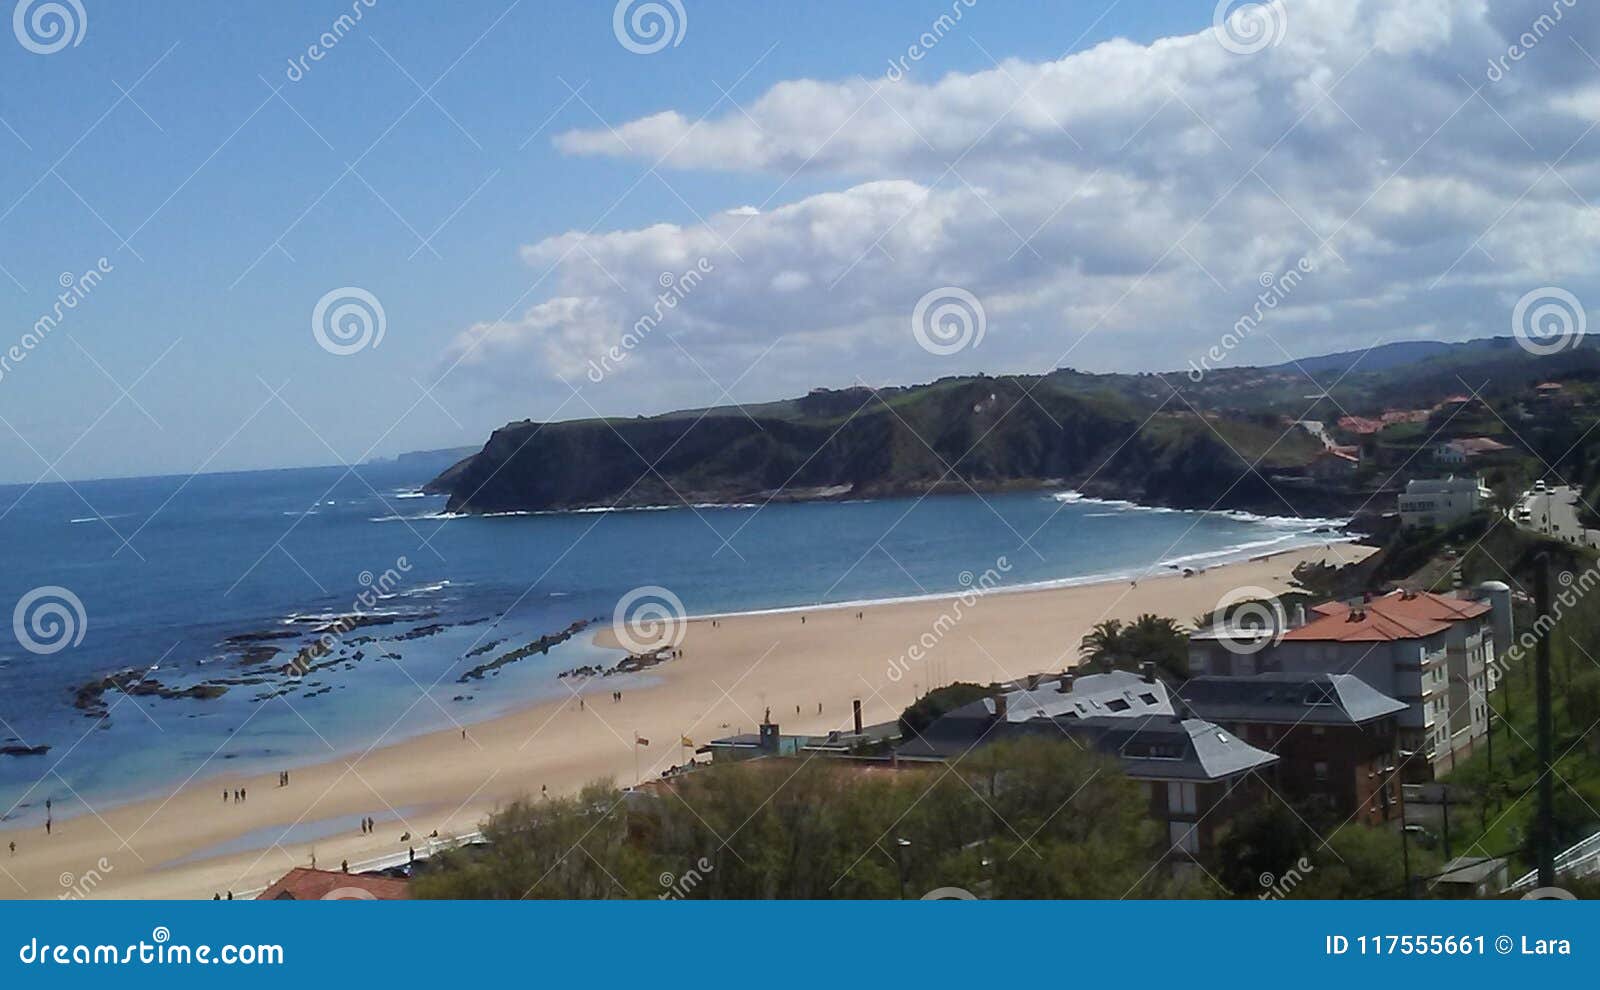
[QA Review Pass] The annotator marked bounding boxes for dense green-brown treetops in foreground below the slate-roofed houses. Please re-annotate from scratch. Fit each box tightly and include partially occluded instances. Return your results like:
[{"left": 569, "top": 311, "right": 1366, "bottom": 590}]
[{"left": 416, "top": 739, "right": 1216, "bottom": 899}]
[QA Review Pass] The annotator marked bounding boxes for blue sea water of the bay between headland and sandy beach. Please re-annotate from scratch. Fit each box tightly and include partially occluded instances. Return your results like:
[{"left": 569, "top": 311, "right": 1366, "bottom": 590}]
[{"left": 0, "top": 462, "right": 1350, "bottom": 822}]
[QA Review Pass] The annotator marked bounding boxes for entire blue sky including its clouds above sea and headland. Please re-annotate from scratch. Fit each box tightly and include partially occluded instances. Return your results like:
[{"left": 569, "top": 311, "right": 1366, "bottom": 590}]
[{"left": 0, "top": 0, "right": 1600, "bottom": 483}]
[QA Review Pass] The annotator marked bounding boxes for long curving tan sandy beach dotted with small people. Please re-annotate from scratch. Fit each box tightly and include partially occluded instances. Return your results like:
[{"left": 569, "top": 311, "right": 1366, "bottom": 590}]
[{"left": 0, "top": 544, "right": 1371, "bottom": 899}]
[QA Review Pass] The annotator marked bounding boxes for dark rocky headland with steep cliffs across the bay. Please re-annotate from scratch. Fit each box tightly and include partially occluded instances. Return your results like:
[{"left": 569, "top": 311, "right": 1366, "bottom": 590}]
[{"left": 429, "top": 377, "right": 1322, "bottom": 513}]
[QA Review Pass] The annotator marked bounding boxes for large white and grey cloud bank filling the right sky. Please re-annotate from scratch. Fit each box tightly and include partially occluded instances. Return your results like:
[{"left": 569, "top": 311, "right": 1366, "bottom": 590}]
[{"left": 454, "top": 0, "right": 1600, "bottom": 411}]
